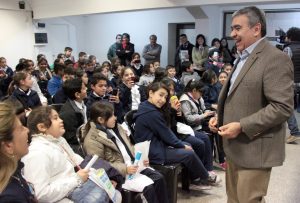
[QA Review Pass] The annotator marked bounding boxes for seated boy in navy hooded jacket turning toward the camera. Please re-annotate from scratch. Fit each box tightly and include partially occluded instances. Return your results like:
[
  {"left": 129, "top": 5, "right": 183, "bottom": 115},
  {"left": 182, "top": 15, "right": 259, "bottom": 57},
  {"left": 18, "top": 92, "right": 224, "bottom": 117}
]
[{"left": 134, "top": 82, "right": 219, "bottom": 185}]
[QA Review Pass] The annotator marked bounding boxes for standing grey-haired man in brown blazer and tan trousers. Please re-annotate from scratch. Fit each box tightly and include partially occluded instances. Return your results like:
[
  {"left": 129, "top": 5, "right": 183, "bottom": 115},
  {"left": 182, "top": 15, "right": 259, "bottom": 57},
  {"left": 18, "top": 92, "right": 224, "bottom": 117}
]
[{"left": 209, "top": 7, "right": 293, "bottom": 203}]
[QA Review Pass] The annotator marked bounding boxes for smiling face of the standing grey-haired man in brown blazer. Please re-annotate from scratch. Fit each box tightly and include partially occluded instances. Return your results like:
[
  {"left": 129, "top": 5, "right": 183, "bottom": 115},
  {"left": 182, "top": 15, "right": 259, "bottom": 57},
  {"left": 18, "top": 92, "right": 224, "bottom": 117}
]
[{"left": 231, "top": 15, "right": 261, "bottom": 52}]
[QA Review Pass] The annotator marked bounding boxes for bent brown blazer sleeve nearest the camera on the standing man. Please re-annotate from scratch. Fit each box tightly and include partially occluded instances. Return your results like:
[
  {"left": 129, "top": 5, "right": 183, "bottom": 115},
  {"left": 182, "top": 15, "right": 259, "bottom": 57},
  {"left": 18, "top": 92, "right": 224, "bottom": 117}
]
[{"left": 240, "top": 54, "right": 294, "bottom": 139}]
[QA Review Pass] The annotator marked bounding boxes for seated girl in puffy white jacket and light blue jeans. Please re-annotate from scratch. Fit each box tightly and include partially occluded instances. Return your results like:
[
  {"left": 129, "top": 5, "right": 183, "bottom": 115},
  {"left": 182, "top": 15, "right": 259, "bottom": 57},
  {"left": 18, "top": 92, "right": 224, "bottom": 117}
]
[{"left": 22, "top": 107, "right": 109, "bottom": 203}]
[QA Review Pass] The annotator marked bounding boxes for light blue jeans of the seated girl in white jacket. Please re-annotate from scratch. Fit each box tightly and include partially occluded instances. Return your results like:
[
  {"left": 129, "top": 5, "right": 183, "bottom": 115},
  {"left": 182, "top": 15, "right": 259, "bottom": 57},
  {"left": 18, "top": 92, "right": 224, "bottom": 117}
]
[{"left": 68, "top": 179, "right": 109, "bottom": 203}]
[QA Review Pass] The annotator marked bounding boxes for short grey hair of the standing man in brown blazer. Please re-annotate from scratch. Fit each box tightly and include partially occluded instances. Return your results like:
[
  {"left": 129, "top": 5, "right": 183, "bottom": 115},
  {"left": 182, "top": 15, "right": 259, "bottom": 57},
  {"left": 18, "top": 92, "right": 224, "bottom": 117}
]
[{"left": 232, "top": 6, "right": 267, "bottom": 37}]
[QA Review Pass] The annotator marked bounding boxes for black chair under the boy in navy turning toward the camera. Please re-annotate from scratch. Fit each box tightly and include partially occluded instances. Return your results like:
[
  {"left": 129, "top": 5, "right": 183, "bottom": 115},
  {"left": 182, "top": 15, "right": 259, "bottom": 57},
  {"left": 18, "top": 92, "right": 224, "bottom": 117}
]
[{"left": 124, "top": 110, "right": 190, "bottom": 203}]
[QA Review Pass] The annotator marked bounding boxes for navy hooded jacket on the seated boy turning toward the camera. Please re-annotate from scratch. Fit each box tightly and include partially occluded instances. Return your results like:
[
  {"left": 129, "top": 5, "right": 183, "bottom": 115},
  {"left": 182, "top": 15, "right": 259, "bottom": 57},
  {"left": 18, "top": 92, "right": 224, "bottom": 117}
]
[{"left": 134, "top": 101, "right": 184, "bottom": 164}]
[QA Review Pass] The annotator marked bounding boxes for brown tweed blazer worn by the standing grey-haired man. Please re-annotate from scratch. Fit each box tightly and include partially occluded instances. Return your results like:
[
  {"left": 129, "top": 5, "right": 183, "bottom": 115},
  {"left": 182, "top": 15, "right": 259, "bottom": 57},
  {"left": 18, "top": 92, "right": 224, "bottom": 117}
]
[{"left": 218, "top": 40, "right": 293, "bottom": 168}]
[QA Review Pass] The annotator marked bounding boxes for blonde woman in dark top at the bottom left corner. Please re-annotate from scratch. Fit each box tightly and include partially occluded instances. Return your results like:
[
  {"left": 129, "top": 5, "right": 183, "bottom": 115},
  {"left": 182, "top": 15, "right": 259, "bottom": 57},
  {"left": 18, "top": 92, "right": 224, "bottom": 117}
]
[{"left": 0, "top": 103, "right": 37, "bottom": 203}]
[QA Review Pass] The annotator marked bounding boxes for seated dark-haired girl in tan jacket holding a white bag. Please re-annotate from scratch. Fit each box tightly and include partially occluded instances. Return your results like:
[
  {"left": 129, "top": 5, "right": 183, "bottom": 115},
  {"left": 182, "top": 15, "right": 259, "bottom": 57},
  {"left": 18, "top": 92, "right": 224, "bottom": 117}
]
[{"left": 84, "top": 102, "right": 168, "bottom": 203}]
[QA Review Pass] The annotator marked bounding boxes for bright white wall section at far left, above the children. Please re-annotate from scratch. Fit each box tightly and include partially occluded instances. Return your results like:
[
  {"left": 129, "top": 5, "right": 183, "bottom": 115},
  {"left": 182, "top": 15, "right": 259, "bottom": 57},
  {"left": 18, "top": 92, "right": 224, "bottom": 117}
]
[{"left": 0, "top": 9, "right": 34, "bottom": 69}]
